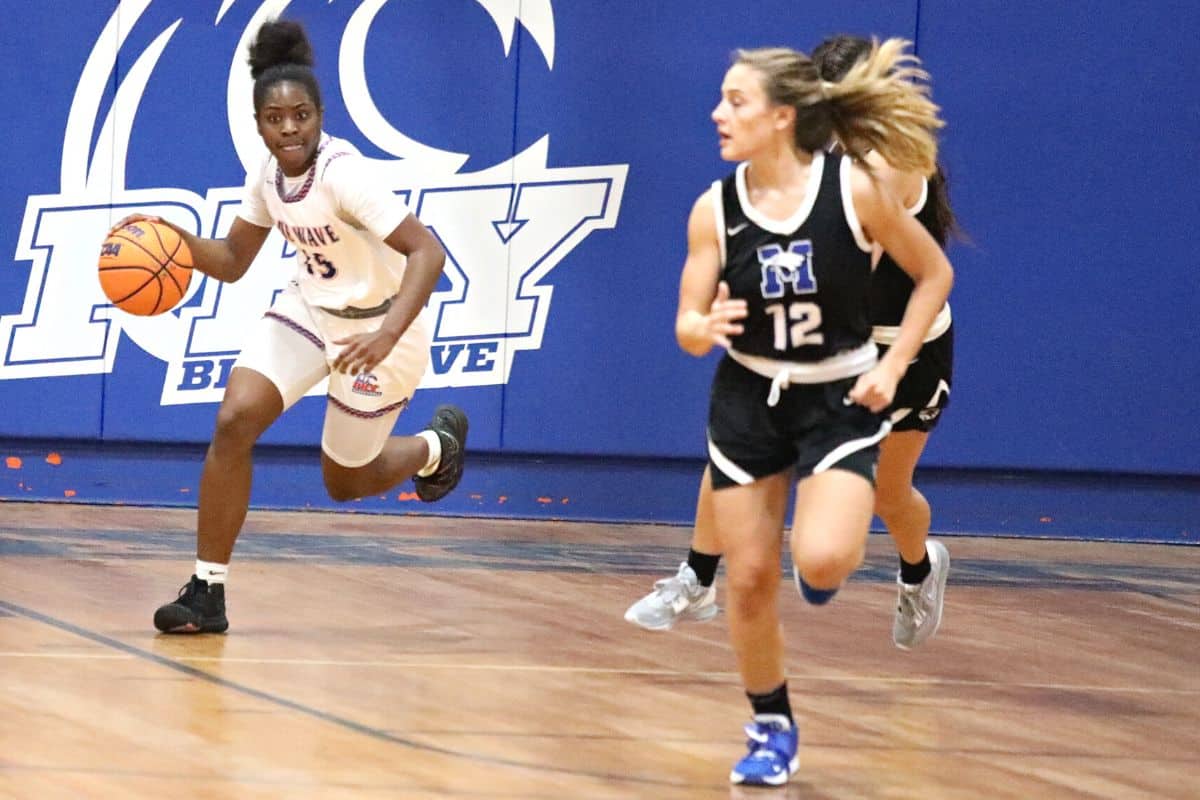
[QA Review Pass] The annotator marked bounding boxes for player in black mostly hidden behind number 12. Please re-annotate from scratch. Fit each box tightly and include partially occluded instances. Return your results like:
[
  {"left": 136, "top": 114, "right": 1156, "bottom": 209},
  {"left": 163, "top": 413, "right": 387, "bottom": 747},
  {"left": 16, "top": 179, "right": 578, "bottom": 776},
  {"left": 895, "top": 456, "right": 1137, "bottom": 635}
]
[{"left": 625, "top": 36, "right": 955, "bottom": 649}]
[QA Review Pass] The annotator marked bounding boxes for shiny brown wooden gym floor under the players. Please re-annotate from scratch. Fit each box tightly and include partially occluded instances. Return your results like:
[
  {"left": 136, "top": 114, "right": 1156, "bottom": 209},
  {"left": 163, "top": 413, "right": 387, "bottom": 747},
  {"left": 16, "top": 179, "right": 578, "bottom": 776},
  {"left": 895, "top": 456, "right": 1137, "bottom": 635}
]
[{"left": 0, "top": 504, "right": 1200, "bottom": 800}]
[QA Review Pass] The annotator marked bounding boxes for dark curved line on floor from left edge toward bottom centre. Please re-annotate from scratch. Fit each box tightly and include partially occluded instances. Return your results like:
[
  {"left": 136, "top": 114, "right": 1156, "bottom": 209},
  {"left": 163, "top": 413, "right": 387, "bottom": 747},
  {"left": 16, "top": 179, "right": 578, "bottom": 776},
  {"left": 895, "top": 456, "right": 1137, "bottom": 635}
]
[{"left": 0, "top": 600, "right": 714, "bottom": 789}]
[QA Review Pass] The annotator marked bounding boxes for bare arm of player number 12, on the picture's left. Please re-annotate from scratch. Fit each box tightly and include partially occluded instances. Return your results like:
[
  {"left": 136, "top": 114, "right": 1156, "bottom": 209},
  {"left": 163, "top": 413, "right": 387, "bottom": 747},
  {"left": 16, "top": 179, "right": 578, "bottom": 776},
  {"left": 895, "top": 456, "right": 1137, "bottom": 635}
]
[{"left": 676, "top": 190, "right": 746, "bottom": 356}]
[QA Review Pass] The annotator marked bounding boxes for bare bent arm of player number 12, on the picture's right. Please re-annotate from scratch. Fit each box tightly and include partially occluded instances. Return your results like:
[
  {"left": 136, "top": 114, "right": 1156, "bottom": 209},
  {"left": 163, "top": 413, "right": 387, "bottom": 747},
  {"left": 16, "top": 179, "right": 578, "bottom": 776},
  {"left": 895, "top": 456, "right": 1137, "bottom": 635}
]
[{"left": 850, "top": 168, "right": 954, "bottom": 411}]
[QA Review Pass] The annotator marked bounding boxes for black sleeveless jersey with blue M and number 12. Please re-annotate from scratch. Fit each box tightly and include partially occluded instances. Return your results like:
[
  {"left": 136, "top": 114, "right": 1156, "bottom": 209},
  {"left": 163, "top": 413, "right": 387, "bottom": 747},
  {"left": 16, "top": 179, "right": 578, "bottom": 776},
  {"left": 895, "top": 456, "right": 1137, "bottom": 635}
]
[{"left": 716, "top": 152, "right": 871, "bottom": 362}]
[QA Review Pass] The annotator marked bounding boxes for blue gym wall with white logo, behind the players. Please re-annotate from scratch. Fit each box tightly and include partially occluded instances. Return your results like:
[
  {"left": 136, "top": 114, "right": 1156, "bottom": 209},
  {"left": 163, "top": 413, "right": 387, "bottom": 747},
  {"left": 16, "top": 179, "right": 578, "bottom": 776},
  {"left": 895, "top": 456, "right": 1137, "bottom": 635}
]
[{"left": 0, "top": 0, "right": 1200, "bottom": 542}]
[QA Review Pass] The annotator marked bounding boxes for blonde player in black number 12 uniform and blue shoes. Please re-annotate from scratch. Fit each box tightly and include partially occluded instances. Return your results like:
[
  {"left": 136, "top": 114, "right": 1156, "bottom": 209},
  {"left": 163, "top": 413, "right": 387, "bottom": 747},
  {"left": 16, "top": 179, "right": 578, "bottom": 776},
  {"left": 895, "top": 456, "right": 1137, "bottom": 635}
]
[{"left": 676, "top": 40, "right": 953, "bottom": 784}]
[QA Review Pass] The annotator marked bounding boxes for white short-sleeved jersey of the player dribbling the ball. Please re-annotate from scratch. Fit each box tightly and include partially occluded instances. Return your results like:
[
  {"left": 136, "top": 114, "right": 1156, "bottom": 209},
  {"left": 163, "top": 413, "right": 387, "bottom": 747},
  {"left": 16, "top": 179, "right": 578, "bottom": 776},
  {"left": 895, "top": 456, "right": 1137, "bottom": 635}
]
[{"left": 238, "top": 133, "right": 412, "bottom": 308}]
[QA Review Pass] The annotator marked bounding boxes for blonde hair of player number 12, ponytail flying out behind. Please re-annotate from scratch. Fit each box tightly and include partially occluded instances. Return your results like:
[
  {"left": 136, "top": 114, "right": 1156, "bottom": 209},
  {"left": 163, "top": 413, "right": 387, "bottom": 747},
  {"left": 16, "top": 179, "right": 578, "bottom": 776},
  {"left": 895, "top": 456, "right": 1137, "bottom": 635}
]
[{"left": 734, "top": 38, "right": 946, "bottom": 175}]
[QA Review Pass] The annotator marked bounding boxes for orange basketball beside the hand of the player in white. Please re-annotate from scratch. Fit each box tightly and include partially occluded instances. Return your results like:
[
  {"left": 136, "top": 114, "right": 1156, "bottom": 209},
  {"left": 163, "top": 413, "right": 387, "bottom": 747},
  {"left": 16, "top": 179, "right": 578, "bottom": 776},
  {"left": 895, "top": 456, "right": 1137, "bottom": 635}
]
[{"left": 100, "top": 219, "right": 192, "bottom": 317}]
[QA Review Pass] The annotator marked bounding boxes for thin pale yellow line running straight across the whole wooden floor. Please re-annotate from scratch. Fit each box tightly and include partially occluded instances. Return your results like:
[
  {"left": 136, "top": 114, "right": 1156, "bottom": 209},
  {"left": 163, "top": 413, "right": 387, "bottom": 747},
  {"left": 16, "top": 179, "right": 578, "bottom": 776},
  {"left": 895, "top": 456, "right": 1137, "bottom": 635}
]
[{"left": 0, "top": 652, "right": 1200, "bottom": 696}]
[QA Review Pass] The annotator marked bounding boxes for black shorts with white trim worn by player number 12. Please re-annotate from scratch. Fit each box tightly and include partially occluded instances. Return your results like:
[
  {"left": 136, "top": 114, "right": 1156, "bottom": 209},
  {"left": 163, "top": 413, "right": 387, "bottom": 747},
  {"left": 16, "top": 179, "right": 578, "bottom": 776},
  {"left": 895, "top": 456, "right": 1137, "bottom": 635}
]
[{"left": 708, "top": 356, "right": 890, "bottom": 489}]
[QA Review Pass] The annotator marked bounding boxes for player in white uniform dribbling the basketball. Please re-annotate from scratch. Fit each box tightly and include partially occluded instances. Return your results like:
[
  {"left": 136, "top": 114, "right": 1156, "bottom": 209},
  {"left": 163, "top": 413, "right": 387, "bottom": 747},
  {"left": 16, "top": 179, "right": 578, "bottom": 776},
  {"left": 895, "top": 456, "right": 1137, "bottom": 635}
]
[{"left": 108, "top": 20, "right": 467, "bottom": 633}]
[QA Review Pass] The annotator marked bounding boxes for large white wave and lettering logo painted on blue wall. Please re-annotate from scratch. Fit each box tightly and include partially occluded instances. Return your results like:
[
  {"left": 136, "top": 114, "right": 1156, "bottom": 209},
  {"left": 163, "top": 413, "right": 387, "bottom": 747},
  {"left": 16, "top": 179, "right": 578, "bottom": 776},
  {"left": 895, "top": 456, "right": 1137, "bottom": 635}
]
[{"left": 0, "top": 0, "right": 628, "bottom": 405}]
